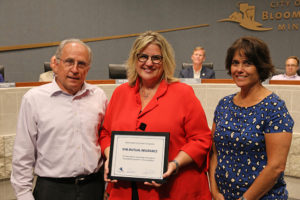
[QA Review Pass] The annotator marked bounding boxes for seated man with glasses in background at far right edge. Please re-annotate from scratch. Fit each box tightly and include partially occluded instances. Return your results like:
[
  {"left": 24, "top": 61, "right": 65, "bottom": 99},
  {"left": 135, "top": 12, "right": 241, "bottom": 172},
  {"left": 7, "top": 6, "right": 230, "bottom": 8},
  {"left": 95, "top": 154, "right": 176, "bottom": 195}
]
[{"left": 271, "top": 56, "right": 300, "bottom": 80}]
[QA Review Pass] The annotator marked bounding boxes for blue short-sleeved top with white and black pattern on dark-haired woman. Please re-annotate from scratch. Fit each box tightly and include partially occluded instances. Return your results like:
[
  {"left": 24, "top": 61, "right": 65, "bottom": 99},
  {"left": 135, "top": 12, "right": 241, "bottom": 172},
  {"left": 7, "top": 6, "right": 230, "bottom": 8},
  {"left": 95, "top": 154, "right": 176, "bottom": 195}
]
[{"left": 214, "top": 93, "right": 294, "bottom": 200}]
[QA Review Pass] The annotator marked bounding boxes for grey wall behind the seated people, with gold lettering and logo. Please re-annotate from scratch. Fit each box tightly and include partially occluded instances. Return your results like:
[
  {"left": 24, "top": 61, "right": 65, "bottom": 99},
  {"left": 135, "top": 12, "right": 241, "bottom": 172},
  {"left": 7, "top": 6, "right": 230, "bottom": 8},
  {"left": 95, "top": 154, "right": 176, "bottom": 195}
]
[{"left": 0, "top": 0, "right": 300, "bottom": 82}]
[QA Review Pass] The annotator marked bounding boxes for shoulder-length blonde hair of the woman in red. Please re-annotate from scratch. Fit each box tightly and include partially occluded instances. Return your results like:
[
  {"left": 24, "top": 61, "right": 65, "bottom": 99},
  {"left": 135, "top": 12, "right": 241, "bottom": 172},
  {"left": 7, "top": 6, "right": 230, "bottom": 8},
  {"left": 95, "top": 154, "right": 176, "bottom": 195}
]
[{"left": 127, "top": 31, "right": 178, "bottom": 86}]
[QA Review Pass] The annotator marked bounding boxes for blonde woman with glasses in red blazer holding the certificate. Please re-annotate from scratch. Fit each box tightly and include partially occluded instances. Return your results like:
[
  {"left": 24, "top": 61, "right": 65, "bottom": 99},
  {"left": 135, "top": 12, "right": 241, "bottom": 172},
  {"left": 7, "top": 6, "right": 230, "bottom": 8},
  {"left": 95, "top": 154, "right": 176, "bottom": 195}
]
[{"left": 100, "top": 31, "right": 211, "bottom": 200}]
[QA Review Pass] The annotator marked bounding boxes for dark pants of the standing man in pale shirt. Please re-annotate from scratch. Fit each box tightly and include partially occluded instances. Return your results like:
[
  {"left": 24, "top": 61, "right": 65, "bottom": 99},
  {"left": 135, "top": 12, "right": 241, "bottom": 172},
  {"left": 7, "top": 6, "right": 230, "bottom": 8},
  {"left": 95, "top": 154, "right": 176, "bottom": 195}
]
[{"left": 33, "top": 173, "right": 104, "bottom": 200}]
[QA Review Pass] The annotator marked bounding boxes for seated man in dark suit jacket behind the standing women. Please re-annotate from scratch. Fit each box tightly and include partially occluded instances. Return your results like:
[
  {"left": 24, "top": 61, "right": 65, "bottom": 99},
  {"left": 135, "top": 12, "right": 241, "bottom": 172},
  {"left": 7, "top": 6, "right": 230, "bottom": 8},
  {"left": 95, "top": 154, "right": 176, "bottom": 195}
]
[{"left": 179, "top": 47, "right": 215, "bottom": 79}]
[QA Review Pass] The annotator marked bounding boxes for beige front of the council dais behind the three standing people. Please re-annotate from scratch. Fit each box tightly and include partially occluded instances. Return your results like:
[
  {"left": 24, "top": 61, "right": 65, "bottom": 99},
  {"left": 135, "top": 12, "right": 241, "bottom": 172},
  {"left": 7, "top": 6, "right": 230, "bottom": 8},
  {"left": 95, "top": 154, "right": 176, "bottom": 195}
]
[{"left": 0, "top": 84, "right": 300, "bottom": 199}]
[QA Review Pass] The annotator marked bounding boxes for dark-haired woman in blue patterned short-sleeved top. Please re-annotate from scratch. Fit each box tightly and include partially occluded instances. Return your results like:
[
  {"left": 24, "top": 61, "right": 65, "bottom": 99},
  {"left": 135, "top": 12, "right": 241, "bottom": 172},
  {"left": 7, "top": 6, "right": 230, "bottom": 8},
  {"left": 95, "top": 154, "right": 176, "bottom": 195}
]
[{"left": 209, "top": 37, "right": 294, "bottom": 200}]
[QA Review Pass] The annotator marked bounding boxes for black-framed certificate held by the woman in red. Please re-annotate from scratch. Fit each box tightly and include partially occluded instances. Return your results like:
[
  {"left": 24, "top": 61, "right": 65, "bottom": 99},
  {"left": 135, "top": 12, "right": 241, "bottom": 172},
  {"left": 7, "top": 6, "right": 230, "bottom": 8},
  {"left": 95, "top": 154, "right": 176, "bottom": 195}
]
[{"left": 108, "top": 131, "right": 169, "bottom": 183}]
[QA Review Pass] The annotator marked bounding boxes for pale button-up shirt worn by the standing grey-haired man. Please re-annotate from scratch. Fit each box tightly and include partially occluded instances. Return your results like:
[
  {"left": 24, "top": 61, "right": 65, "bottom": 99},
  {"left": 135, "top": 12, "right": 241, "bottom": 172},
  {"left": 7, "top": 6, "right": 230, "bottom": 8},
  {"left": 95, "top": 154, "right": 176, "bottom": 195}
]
[{"left": 11, "top": 80, "right": 107, "bottom": 200}]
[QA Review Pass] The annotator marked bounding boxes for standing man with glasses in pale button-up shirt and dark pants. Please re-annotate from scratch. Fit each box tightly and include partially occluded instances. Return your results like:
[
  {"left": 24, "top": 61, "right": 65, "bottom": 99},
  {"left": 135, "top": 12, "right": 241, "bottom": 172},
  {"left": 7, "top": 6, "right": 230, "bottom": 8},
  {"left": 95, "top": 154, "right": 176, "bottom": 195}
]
[{"left": 11, "top": 39, "right": 107, "bottom": 200}]
